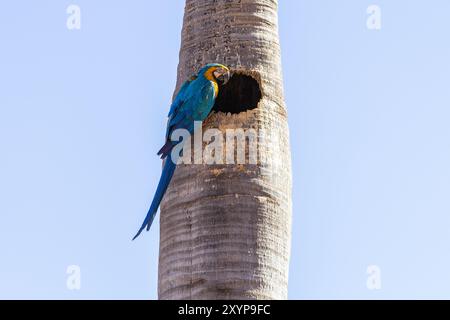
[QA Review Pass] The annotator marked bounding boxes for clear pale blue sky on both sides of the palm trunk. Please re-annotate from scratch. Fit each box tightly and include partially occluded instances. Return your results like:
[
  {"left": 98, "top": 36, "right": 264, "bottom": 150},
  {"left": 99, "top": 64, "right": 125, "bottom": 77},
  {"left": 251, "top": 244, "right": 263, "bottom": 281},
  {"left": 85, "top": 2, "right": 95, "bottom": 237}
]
[{"left": 0, "top": 0, "right": 450, "bottom": 299}]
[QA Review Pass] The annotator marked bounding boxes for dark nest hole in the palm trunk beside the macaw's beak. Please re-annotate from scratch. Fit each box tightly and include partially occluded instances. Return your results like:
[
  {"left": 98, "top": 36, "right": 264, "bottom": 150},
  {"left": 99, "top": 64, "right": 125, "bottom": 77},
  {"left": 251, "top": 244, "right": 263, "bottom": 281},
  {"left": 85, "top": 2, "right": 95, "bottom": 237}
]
[{"left": 213, "top": 73, "right": 262, "bottom": 114}]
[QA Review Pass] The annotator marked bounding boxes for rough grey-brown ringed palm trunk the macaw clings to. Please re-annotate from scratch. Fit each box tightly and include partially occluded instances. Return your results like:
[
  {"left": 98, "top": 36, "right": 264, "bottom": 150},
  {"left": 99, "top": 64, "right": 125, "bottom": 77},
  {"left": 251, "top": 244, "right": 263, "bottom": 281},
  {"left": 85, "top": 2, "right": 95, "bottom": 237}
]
[{"left": 158, "top": 0, "right": 291, "bottom": 299}]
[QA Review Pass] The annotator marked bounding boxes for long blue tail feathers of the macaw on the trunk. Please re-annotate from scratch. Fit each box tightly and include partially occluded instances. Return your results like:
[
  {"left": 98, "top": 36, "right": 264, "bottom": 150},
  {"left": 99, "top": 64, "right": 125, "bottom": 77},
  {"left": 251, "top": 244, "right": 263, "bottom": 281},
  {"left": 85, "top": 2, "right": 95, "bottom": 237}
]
[{"left": 133, "top": 155, "right": 176, "bottom": 240}]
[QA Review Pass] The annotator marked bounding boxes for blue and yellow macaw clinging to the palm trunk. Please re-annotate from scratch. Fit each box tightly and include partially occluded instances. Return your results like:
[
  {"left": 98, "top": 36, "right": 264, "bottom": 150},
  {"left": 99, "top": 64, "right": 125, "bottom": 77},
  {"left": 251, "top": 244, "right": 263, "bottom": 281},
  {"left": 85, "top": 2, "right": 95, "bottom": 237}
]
[{"left": 133, "top": 63, "right": 230, "bottom": 240}]
